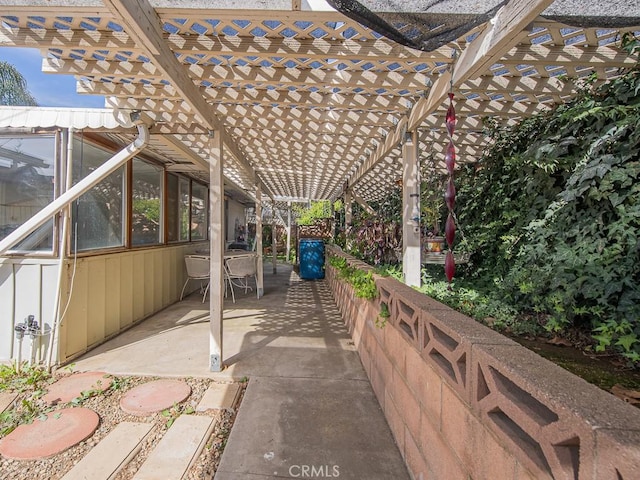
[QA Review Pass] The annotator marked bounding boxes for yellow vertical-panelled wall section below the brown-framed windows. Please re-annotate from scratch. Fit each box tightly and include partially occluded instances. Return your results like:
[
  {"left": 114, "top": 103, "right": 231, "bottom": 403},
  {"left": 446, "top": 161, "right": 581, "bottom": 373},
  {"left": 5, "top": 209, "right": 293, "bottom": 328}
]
[{"left": 59, "top": 245, "right": 202, "bottom": 362}]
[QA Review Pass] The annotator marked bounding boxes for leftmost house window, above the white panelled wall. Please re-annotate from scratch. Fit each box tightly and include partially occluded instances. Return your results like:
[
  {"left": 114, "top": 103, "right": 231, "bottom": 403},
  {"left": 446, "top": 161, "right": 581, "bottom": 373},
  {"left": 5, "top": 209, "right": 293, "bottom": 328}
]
[{"left": 0, "top": 135, "right": 56, "bottom": 252}]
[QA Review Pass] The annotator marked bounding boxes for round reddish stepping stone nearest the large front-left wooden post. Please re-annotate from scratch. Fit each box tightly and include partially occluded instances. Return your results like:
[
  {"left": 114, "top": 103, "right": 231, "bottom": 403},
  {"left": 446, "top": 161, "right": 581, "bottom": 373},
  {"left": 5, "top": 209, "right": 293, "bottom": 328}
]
[{"left": 120, "top": 380, "right": 191, "bottom": 417}]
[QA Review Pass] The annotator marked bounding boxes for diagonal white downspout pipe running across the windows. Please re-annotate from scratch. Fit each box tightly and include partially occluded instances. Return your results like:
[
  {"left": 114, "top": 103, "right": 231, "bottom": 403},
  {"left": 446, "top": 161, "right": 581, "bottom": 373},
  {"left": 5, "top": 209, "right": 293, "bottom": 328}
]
[{"left": 0, "top": 125, "right": 149, "bottom": 255}]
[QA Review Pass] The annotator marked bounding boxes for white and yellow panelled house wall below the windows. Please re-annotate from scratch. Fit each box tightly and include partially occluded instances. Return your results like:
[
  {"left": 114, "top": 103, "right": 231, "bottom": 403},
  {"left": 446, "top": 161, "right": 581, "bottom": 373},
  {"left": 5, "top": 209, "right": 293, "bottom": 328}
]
[{"left": 0, "top": 244, "right": 202, "bottom": 364}]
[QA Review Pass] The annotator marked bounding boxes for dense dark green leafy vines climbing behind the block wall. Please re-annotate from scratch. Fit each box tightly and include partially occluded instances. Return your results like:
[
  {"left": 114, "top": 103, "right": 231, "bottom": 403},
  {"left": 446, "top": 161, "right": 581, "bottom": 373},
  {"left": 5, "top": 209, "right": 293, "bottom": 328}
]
[{"left": 456, "top": 50, "right": 640, "bottom": 362}]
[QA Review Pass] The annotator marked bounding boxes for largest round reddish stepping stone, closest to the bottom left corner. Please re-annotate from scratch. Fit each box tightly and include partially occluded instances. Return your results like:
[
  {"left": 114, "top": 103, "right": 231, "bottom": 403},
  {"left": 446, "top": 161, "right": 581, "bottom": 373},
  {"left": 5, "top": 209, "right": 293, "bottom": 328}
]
[{"left": 0, "top": 408, "right": 100, "bottom": 460}]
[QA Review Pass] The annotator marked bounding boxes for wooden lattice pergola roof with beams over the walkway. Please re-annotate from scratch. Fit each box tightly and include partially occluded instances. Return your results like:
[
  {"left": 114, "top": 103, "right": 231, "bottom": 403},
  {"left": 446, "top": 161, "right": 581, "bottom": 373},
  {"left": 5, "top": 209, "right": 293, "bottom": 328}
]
[{"left": 0, "top": 0, "right": 640, "bottom": 206}]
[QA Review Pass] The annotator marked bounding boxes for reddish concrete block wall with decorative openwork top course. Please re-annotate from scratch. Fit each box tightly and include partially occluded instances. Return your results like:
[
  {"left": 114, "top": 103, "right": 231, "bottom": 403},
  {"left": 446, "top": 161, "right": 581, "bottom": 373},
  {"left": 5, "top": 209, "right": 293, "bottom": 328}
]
[{"left": 326, "top": 248, "right": 640, "bottom": 480}]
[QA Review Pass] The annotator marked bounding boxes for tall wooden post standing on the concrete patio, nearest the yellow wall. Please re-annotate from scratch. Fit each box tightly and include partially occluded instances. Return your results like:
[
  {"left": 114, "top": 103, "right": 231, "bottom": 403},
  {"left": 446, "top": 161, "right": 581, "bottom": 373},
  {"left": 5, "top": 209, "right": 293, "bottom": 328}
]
[{"left": 209, "top": 130, "right": 224, "bottom": 372}]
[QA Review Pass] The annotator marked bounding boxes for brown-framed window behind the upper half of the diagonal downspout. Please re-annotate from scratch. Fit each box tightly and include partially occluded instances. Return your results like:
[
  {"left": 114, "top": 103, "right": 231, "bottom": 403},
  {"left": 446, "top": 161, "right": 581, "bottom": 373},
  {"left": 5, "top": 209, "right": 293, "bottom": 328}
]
[{"left": 71, "top": 138, "right": 125, "bottom": 251}]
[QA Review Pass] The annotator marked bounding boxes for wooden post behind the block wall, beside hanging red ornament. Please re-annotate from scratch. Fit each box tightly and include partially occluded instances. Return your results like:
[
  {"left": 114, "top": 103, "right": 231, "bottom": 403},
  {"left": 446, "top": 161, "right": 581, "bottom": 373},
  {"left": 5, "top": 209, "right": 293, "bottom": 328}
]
[{"left": 402, "top": 131, "right": 421, "bottom": 287}]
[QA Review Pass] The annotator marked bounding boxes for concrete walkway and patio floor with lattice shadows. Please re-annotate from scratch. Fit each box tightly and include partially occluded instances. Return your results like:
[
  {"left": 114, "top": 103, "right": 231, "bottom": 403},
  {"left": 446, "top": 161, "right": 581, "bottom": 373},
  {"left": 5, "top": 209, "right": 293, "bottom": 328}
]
[{"left": 75, "top": 264, "right": 409, "bottom": 480}]
